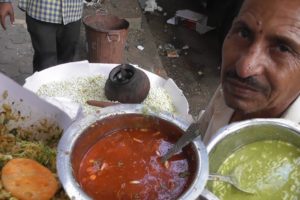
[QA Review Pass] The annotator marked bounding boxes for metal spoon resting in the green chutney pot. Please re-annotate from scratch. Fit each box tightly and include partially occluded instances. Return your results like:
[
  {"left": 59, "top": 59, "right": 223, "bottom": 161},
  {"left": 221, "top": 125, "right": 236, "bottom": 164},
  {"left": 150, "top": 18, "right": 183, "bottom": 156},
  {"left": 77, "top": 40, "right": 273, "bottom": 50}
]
[{"left": 208, "top": 174, "right": 255, "bottom": 194}]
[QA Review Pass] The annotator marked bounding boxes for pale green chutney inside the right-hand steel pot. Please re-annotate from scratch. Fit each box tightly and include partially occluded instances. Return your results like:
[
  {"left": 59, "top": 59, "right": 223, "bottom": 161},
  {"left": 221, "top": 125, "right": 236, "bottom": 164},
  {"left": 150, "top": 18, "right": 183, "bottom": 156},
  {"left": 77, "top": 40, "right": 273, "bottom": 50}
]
[{"left": 212, "top": 140, "right": 300, "bottom": 200}]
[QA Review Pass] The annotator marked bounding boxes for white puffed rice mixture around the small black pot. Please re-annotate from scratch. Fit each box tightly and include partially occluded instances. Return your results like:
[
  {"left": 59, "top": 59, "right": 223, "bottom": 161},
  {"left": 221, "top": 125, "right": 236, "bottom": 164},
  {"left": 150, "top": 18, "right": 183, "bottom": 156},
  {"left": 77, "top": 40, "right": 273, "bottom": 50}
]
[{"left": 37, "top": 75, "right": 176, "bottom": 114}]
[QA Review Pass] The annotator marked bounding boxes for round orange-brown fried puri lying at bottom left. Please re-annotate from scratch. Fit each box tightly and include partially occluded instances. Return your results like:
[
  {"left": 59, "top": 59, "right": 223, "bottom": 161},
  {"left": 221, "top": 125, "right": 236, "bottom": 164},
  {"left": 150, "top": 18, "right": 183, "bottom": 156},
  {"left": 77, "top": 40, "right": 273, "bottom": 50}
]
[{"left": 2, "top": 158, "right": 58, "bottom": 200}]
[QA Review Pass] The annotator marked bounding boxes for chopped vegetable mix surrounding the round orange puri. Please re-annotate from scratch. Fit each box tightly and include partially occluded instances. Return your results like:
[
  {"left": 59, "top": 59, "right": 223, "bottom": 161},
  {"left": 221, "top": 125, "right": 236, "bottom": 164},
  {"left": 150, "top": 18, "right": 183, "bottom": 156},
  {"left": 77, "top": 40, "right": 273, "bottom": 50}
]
[{"left": 0, "top": 94, "right": 65, "bottom": 200}]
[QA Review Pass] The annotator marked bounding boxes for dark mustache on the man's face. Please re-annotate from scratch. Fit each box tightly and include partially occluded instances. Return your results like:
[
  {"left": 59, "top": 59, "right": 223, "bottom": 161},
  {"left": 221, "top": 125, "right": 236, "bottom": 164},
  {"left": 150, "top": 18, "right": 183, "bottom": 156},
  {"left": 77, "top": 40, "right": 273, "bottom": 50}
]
[{"left": 225, "top": 70, "right": 269, "bottom": 92}]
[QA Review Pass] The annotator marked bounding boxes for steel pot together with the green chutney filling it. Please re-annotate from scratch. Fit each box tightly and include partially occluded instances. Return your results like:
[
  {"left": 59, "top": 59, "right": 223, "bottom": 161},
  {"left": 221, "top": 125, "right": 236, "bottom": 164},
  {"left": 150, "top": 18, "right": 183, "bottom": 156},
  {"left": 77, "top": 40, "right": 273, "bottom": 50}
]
[{"left": 207, "top": 119, "right": 300, "bottom": 200}]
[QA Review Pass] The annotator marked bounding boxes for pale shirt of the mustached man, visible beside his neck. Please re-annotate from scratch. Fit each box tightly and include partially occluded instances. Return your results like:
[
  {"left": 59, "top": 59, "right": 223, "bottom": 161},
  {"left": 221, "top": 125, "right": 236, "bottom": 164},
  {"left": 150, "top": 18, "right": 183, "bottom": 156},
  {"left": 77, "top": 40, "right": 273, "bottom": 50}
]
[{"left": 202, "top": 86, "right": 300, "bottom": 145}]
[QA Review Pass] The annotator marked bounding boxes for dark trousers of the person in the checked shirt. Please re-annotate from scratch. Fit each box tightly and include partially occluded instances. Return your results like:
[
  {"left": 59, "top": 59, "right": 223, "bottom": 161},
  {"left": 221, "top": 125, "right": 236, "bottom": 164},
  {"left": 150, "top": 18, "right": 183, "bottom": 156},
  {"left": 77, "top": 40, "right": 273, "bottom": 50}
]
[{"left": 26, "top": 15, "right": 81, "bottom": 72}]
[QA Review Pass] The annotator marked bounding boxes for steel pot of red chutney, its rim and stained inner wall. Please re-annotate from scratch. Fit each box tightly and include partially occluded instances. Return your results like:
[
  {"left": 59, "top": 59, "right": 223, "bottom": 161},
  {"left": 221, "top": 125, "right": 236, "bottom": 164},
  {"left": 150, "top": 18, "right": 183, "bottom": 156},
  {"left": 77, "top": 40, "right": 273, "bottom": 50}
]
[{"left": 57, "top": 104, "right": 208, "bottom": 200}]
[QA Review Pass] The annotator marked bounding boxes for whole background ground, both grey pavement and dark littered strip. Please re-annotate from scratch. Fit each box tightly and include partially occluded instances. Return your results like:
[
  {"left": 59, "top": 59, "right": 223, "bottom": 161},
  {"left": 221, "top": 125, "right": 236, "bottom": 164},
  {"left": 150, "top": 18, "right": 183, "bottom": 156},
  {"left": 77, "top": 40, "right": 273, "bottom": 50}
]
[{"left": 0, "top": 0, "right": 220, "bottom": 115}]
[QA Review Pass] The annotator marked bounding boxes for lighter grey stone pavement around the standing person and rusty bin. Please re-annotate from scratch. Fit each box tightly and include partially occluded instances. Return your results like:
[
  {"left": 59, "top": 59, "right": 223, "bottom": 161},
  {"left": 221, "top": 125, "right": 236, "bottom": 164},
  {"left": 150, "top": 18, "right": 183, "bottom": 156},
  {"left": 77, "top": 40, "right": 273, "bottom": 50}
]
[{"left": 0, "top": 0, "right": 166, "bottom": 85}]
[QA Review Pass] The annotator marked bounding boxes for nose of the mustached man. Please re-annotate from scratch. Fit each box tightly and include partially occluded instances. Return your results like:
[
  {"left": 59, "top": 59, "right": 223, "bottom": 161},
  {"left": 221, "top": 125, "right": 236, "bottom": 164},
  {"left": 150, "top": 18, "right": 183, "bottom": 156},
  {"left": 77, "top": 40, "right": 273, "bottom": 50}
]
[{"left": 236, "top": 45, "right": 266, "bottom": 78}]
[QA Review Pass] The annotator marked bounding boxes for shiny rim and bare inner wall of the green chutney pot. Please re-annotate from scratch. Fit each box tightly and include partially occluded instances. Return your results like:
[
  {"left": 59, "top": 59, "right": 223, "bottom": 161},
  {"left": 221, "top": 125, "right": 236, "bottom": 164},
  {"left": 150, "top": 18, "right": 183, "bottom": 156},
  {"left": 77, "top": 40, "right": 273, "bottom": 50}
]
[{"left": 207, "top": 119, "right": 300, "bottom": 173}]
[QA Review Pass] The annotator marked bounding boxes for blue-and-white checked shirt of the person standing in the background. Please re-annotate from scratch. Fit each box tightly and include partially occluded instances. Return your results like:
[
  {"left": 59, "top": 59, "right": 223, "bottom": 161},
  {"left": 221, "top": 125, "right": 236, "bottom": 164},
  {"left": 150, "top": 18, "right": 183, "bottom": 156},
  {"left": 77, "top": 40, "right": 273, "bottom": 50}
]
[{"left": 0, "top": 0, "right": 83, "bottom": 24}]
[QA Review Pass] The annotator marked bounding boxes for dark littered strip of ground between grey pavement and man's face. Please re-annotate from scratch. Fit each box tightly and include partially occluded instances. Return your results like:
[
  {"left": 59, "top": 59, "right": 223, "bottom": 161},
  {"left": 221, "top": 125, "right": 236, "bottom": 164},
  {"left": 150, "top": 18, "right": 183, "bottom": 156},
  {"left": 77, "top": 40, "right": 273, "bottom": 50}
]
[{"left": 147, "top": 0, "right": 220, "bottom": 115}]
